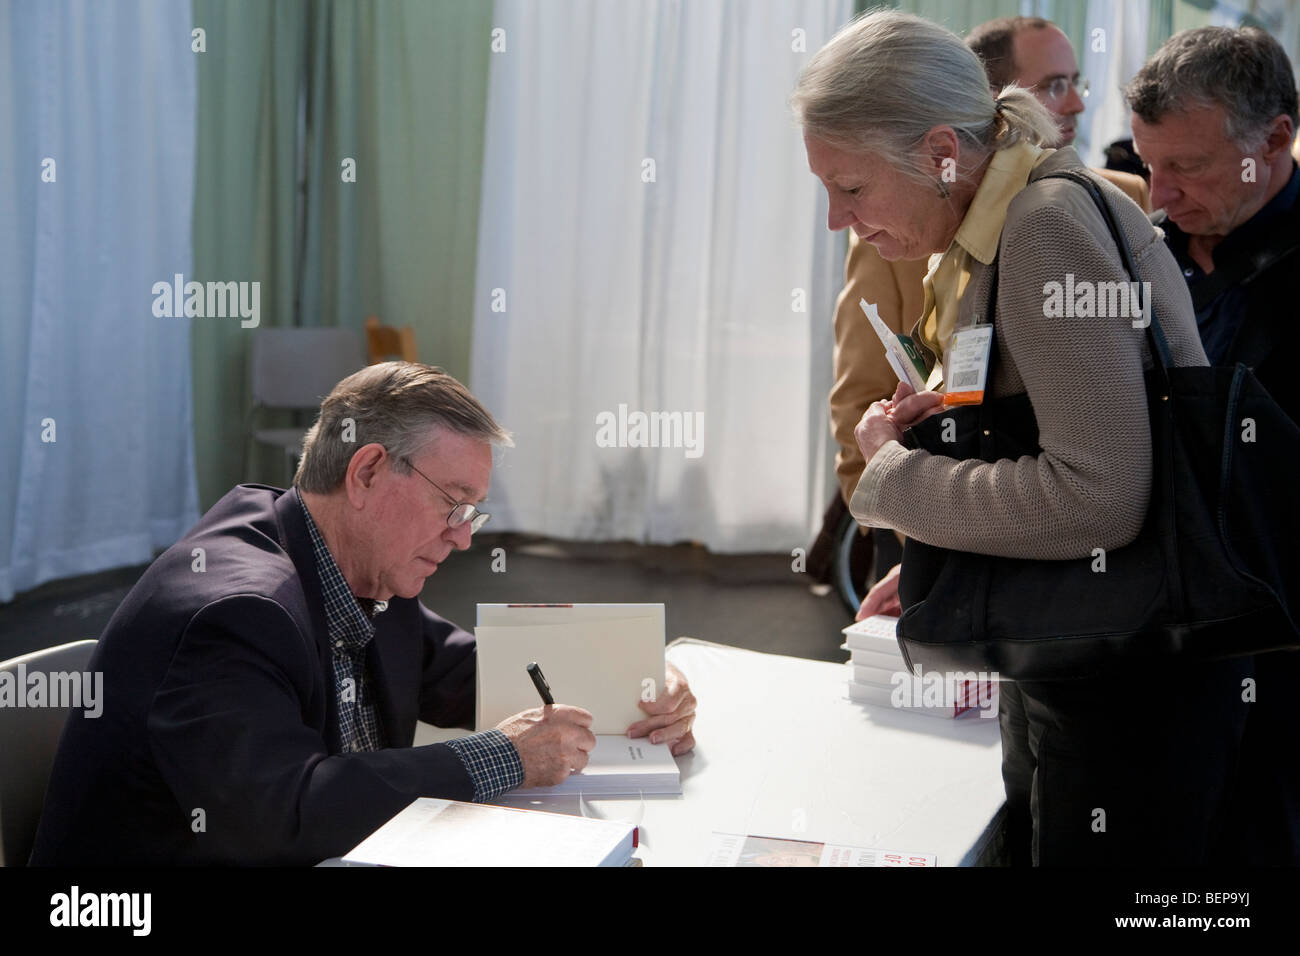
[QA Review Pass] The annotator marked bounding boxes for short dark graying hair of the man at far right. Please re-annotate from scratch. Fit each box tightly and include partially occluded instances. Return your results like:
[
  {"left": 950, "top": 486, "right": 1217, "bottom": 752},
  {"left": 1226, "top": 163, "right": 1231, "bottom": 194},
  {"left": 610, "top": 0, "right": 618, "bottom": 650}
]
[{"left": 1125, "top": 26, "right": 1300, "bottom": 151}]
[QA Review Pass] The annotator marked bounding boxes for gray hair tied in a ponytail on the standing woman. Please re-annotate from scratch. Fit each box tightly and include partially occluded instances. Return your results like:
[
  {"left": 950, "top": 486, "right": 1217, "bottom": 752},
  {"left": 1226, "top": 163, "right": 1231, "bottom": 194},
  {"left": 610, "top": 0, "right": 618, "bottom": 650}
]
[{"left": 790, "top": 10, "right": 1060, "bottom": 179}]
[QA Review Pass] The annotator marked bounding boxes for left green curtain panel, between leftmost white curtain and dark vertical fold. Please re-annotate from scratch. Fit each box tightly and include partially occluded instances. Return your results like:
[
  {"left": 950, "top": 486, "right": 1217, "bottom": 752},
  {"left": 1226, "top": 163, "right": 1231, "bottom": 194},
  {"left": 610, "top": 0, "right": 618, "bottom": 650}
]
[{"left": 187, "top": 0, "right": 307, "bottom": 510}]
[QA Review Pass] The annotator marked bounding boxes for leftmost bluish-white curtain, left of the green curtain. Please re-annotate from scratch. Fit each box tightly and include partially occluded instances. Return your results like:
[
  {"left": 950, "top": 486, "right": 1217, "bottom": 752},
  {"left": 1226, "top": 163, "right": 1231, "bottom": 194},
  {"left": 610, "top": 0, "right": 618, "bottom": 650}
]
[{"left": 0, "top": 0, "right": 198, "bottom": 601}]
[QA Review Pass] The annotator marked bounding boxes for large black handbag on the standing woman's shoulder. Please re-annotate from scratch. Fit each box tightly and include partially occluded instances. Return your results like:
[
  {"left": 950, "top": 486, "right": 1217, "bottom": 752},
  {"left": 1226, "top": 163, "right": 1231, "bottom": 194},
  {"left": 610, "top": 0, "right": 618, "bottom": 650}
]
[{"left": 898, "top": 172, "right": 1300, "bottom": 680}]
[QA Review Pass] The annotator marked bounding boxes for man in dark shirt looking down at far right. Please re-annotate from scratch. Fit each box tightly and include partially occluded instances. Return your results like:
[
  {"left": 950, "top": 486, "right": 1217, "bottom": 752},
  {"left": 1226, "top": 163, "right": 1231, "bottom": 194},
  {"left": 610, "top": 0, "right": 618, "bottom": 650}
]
[{"left": 1127, "top": 27, "right": 1300, "bottom": 866}]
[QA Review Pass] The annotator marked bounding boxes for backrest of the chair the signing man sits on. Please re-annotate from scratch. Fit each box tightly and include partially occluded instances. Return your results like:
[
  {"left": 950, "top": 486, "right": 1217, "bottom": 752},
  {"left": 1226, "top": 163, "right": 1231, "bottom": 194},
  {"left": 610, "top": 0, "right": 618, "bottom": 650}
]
[{"left": 0, "top": 641, "right": 103, "bottom": 866}]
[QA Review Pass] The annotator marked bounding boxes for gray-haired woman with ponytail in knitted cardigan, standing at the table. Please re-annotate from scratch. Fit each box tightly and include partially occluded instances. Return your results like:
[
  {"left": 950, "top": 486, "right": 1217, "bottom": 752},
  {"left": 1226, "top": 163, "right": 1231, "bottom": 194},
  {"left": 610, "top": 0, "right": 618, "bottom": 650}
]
[{"left": 792, "top": 12, "right": 1248, "bottom": 865}]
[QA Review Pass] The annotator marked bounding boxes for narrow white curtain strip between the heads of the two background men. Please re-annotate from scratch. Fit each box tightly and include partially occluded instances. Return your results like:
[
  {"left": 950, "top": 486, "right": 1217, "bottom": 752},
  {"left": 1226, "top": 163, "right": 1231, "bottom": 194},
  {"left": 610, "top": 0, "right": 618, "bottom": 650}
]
[{"left": 1076, "top": 0, "right": 1151, "bottom": 166}]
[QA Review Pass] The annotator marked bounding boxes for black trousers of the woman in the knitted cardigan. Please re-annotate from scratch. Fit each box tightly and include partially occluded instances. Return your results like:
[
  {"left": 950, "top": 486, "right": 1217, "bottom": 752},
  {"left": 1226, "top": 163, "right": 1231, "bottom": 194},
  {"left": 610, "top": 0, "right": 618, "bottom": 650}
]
[{"left": 998, "top": 658, "right": 1255, "bottom": 866}]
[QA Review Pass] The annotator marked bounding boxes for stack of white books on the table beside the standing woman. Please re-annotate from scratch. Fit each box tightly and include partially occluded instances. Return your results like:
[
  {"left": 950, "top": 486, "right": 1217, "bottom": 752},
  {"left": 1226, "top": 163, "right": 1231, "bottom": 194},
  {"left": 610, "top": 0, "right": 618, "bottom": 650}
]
[{"left": 841, "top": 614, "right": 997, "bottom": 718}]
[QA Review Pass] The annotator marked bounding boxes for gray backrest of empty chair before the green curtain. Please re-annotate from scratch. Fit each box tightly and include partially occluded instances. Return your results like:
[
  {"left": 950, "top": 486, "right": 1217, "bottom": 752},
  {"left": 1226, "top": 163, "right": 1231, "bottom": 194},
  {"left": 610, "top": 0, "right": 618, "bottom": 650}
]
[{"left": 250, "top": 328, "right": 365, "bottom": 408}]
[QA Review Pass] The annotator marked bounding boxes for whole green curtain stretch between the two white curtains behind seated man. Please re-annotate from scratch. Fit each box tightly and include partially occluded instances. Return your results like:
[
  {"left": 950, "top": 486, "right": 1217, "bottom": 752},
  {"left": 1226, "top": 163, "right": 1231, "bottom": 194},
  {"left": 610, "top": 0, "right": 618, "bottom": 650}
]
[{"left": 192, "top": 0, "right": 491, "bottom": 509}]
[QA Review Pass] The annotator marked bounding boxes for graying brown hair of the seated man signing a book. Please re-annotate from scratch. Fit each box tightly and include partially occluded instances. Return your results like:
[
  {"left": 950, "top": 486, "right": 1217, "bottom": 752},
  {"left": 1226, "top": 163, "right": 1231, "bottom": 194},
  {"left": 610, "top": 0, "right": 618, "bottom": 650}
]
[{"left": 294, "top": 362, "right": 514, "bottom": 494}]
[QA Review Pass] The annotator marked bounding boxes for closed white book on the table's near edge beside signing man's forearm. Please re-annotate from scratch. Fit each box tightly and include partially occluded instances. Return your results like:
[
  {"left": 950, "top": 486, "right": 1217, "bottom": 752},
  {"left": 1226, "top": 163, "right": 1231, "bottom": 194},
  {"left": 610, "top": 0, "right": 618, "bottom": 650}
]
[{"left": 343, "top": 797, "right": 638, "bottom": 866}]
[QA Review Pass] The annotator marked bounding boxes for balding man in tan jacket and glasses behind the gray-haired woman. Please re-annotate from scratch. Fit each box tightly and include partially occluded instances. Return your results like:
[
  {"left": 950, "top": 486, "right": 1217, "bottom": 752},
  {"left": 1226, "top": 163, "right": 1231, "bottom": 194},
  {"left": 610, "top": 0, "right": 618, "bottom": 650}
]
[{"left": 831, "top": 17, "right": 1151, "bottom": 629}]
